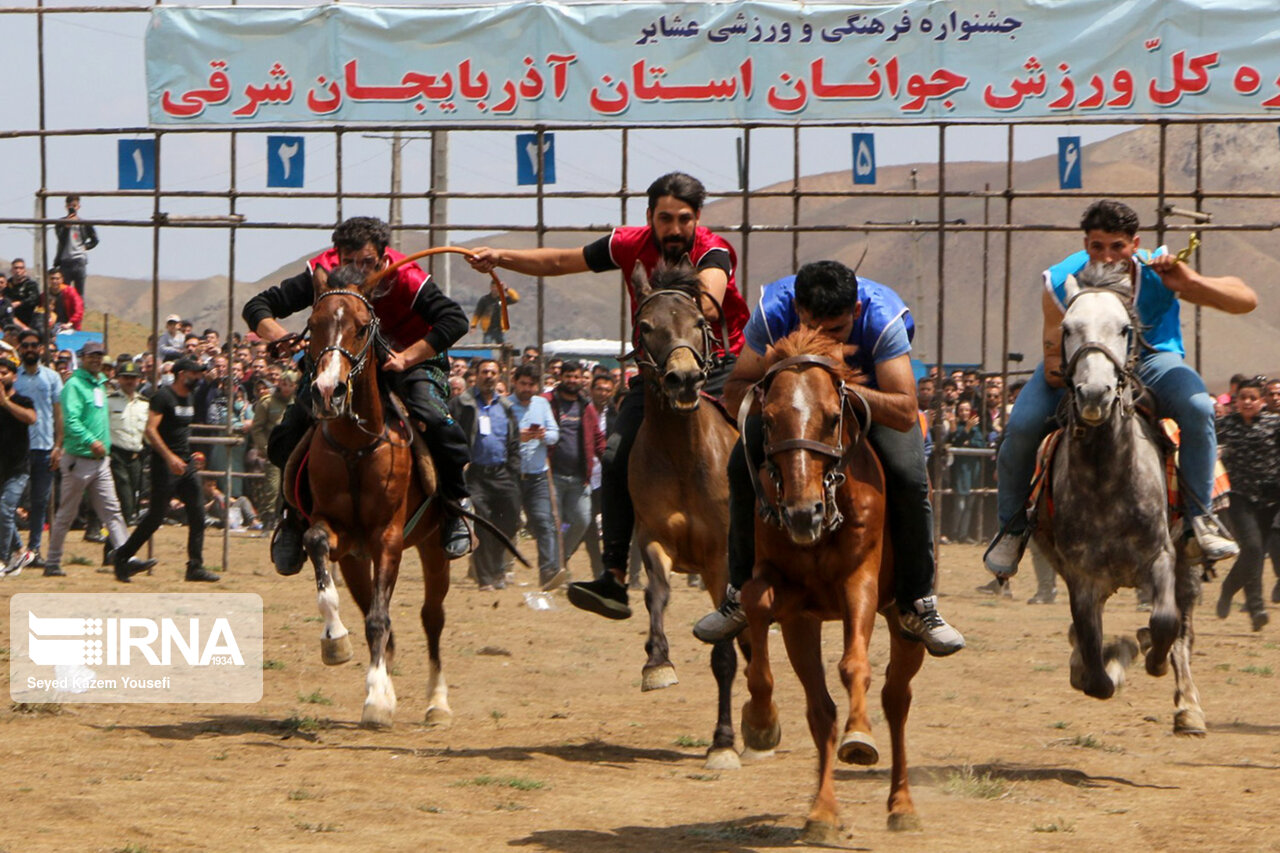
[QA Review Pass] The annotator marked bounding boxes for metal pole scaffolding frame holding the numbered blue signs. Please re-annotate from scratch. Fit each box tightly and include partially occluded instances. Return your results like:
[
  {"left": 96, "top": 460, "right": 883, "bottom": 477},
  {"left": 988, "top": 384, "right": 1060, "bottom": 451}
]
[{"left": 0, "top": 0, "right": 1280, "bottom": 565}]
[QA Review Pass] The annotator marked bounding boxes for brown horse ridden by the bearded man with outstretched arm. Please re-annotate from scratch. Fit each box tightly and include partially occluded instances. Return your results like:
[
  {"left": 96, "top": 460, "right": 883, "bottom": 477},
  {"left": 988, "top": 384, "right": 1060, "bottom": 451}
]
[{"left": 628, "top": 264, "right": 739, "bottom": 770}]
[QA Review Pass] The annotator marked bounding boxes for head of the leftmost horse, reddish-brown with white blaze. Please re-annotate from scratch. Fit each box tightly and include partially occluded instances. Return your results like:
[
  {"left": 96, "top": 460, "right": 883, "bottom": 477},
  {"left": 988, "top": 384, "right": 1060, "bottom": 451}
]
[{"left": 307, "top": 265, "right": 378, "bottom": 420}]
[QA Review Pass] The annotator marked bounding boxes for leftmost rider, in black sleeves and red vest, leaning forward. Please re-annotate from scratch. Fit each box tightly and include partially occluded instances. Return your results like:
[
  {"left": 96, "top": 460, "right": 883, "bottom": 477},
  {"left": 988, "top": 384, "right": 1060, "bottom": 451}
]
[{"left": 242, "top": 216, "right": 471, "bottom": 574}]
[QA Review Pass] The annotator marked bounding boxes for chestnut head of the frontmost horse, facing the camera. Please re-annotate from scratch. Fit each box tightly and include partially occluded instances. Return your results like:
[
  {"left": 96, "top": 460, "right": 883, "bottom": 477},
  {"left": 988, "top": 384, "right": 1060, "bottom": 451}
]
[{"left": 755, "top": 329, "right": 869, "bottom": 546}]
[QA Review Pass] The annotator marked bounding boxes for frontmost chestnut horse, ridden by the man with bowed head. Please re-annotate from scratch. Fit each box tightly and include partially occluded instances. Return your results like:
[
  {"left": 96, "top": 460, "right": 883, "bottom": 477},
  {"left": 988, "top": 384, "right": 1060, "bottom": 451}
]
[{"left": 742, "top": 330, "right": 924, "bottom": 843}]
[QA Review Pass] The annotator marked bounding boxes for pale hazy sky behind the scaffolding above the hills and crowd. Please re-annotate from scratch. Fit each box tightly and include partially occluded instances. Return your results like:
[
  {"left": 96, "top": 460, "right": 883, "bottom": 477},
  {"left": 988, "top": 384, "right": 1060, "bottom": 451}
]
[{"left": 0, "top": 0, "right": 1123, "bottom": 280}]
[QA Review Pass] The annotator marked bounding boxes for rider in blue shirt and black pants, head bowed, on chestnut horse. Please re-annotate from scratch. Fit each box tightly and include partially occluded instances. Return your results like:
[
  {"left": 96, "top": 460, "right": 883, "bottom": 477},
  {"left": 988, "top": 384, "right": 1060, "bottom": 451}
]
[{"left": 694, "top": 261, "right": 964, "bottom": 657}]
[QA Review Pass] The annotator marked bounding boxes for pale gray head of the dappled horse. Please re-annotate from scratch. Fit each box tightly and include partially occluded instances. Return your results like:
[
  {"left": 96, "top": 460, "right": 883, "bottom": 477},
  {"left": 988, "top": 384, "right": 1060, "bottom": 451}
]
[{"left": 1062, "top": 261, "right": 1138, "bottom": 427}]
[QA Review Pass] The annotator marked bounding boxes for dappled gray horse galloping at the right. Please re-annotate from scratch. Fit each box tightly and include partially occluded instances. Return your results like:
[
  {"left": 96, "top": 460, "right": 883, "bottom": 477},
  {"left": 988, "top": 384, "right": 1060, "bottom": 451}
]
[{"left": 1036, "top": 261, "right": 1204, "bottom": 735}]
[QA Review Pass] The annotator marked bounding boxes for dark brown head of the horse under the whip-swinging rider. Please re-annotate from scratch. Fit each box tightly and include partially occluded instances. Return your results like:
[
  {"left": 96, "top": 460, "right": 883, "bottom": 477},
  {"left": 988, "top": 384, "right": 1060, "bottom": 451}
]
[{"left": 631, "top": 264, "right": 712, "bottom": 411}]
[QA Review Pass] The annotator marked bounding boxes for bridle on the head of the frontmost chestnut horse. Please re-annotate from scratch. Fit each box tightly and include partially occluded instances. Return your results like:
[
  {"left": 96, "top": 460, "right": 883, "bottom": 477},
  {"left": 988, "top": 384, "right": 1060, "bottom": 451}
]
[{"left": 737, "top": 355, "right": 872, "bottom": 533}]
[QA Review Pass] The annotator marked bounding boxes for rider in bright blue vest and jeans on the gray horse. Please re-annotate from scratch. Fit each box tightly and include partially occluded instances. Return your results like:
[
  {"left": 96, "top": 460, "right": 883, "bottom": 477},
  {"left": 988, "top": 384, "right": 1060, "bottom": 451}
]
[{"left": 984, "top": 200, "right": 1258, "bottom": 579}]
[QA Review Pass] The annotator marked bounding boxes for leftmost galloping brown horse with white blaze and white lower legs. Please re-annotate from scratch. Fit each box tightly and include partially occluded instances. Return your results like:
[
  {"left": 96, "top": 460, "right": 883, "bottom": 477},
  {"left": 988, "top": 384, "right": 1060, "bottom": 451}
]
[{"left": 303, "top": 266, "right": 453, "bottom": 727}]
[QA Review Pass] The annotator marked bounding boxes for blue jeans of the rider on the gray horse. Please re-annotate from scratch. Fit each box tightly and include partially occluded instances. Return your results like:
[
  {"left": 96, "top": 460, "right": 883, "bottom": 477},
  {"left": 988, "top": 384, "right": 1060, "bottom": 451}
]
[{"left": 996, "top": 352, "right": 1217, "bottom": 533}]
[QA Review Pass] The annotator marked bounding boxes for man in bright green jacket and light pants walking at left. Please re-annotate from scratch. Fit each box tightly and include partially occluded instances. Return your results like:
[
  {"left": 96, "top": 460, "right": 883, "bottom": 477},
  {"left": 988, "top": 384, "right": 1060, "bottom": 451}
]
[{"left": 45, "top": 341, "right": 155, "bottom": 583}]
